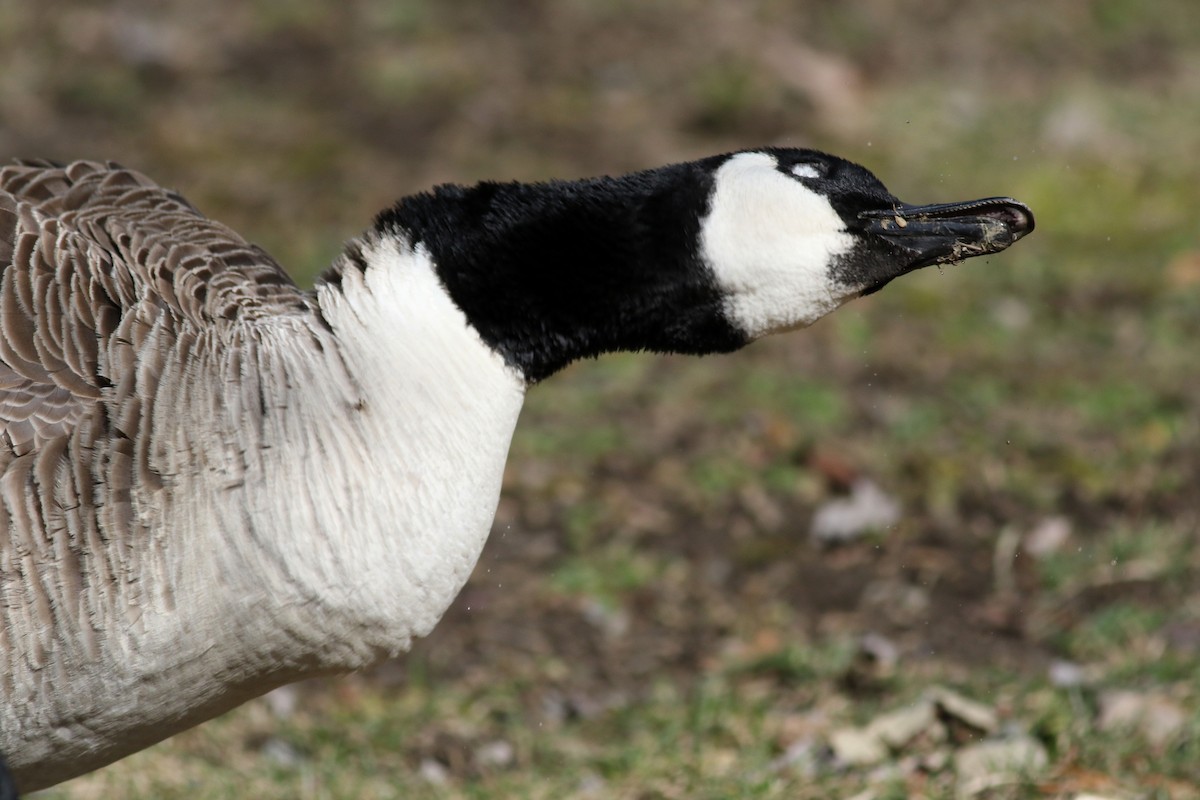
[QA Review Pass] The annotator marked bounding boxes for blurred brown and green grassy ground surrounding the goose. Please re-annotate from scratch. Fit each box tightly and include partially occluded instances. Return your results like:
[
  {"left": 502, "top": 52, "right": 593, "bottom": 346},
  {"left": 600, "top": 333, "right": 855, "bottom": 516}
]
[{"left": 0, "top": 0, "right": 1200, "bottom": 800}]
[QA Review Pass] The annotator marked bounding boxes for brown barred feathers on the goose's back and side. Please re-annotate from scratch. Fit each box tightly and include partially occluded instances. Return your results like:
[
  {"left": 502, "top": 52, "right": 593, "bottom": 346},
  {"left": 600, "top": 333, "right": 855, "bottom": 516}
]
[{"left": 0, "top": 162, "right": 336, "bottom": 787}]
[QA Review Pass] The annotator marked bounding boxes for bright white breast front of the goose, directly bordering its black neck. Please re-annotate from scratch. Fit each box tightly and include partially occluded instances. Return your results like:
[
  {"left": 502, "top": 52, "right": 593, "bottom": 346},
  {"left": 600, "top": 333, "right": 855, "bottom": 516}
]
[{"left": 319, "top": 239, "right": 526, "bottom": 645}]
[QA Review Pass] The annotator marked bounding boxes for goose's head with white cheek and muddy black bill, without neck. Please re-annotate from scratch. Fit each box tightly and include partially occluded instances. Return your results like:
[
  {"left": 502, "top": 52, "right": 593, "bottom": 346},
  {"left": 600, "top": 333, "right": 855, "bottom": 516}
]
[{"left": 700, "top": 149, "right": 1033, "bottom": 338}]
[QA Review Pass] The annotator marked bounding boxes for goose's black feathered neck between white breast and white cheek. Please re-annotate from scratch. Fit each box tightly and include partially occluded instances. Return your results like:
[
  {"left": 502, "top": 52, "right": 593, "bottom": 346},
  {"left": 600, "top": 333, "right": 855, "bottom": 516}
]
[{"left": 376, "top": 162, "right": 746, "bottom": 383}]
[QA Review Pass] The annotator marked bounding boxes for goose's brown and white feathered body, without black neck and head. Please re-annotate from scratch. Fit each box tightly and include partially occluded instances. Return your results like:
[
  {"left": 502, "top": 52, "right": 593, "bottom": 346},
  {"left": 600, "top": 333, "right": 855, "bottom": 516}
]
[{"left": 0, "top": 162, "right": 526, "bottom": 792}]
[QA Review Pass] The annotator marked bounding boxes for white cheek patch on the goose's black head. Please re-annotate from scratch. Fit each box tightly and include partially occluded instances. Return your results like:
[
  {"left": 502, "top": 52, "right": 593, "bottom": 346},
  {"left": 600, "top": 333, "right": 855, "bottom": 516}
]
[{"left": 701, "top": 152, "right": 857, "bottom": 338}]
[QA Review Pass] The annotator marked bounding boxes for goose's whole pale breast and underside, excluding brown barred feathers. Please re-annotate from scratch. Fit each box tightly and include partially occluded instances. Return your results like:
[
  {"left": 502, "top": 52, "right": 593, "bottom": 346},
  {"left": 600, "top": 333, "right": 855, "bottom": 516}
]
[{"left": 0, "top": 240, "right": 524, "bottom": 786}]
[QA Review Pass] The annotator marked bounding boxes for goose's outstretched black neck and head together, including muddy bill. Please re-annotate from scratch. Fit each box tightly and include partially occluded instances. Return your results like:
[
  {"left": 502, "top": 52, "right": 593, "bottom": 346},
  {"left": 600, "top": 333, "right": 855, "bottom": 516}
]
[{"left": 373, "top": 149, "right": 1033, "bottom": 383}]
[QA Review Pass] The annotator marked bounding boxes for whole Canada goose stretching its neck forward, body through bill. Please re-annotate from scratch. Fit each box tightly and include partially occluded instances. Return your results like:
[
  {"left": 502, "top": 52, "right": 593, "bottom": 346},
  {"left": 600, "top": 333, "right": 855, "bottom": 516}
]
[{"left": 0, "top": 149, "right": 1033, "bottom": 792}]
